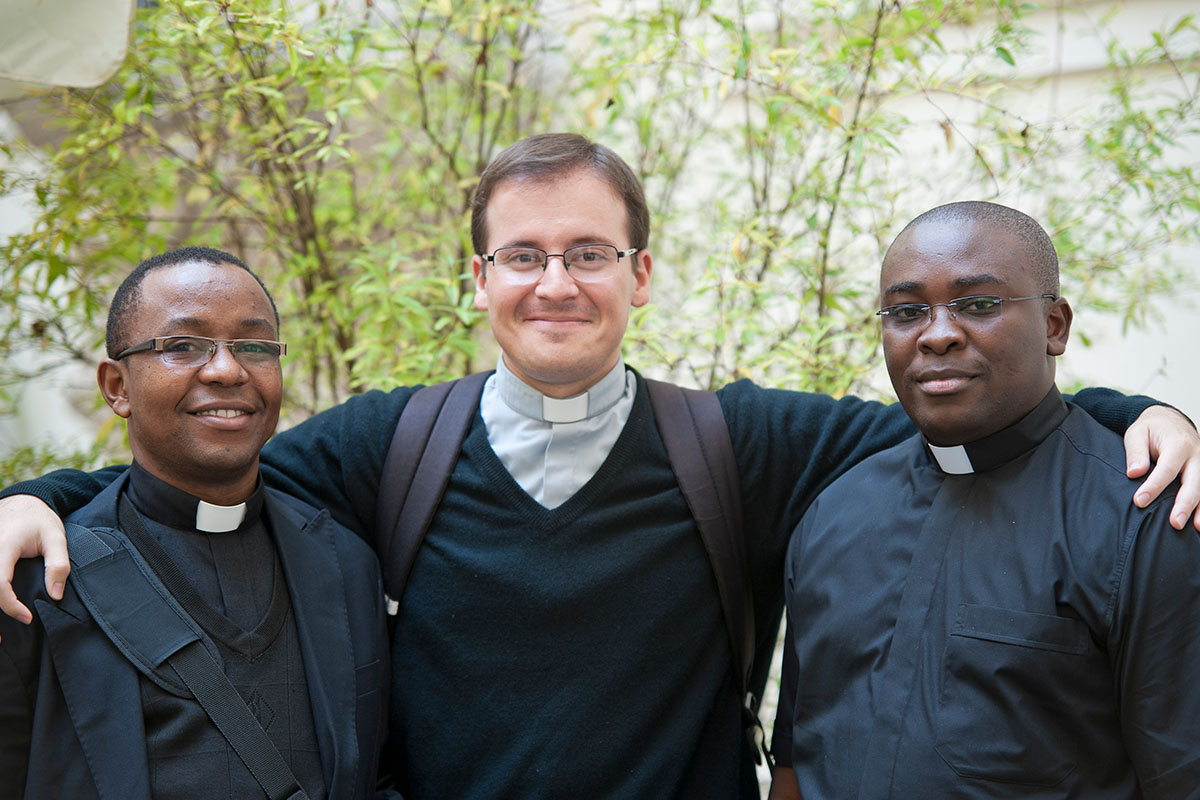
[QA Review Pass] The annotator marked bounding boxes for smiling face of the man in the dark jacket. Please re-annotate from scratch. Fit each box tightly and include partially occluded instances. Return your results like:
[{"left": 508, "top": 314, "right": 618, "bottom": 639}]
[{"left": 98, "top": 261, "right": 283, "bottom": 503}]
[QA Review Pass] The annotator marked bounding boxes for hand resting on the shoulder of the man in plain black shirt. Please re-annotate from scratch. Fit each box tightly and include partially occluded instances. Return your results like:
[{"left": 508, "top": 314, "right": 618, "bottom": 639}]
[{"left": 1124, "top": 405, "right": 1200, "bottom": 530}]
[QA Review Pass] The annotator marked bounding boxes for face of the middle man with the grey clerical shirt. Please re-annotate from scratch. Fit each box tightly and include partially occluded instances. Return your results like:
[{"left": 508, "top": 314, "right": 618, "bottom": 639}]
[{"left": 473, "top": 169, "right": 650, "bottom": 397}]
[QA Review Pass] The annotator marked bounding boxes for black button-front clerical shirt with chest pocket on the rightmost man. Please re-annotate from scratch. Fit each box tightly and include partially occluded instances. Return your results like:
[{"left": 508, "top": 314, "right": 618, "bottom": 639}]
[{"left": 775, "top": 390, "right": 1200, "bottom": 800}]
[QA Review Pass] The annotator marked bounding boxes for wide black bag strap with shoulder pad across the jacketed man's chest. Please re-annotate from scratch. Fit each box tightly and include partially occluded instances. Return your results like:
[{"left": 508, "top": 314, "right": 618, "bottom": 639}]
[{"left": 66, "top": 498, "right": 307, "bottom": 800}]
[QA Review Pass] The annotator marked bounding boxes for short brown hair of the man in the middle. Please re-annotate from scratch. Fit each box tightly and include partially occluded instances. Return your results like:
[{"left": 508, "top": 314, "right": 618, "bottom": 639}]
[{"left": 470, "top": 133, "right": 650, "bottom": 254}]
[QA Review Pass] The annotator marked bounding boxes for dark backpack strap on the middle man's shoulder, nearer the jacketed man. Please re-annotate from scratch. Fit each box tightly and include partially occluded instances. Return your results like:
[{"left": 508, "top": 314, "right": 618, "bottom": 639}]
[{"left": 376, "top": 372, "right": 492, "bottom": 602}]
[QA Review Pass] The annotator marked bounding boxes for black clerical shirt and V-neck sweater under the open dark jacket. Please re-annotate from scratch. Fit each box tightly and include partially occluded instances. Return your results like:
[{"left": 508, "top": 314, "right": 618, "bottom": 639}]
[{"left": 126, "top": 462, "right": 325, "bottom": 800}]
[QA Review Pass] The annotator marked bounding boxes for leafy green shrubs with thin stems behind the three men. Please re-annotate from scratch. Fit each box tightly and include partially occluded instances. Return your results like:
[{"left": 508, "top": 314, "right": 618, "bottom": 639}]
[{"left": 0, "top": 0, "right": 1200, "bottom": 455}]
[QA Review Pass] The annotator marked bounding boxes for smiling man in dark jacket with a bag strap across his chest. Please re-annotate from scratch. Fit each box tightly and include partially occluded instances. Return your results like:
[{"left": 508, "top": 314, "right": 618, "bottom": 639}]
[{"left": 0, "top": 247, "right": 389, "bottom": 800}]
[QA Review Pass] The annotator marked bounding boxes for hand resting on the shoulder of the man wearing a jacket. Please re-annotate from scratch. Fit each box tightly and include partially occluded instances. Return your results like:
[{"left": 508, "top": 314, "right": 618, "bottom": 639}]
[{"left": 0, "top": 494, "right": 71, "bottom": 638}]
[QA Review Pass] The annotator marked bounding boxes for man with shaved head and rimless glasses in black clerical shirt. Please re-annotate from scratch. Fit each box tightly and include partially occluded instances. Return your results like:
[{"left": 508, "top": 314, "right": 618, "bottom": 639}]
[{"left": 772, "top": 203, "right": 1200, "bottom": 800}]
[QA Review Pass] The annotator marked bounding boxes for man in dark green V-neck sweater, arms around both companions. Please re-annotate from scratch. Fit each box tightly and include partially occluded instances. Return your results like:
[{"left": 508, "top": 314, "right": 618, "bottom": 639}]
[{"left": 0, "top": 134, "right": 1200, "bottom": 800}]
